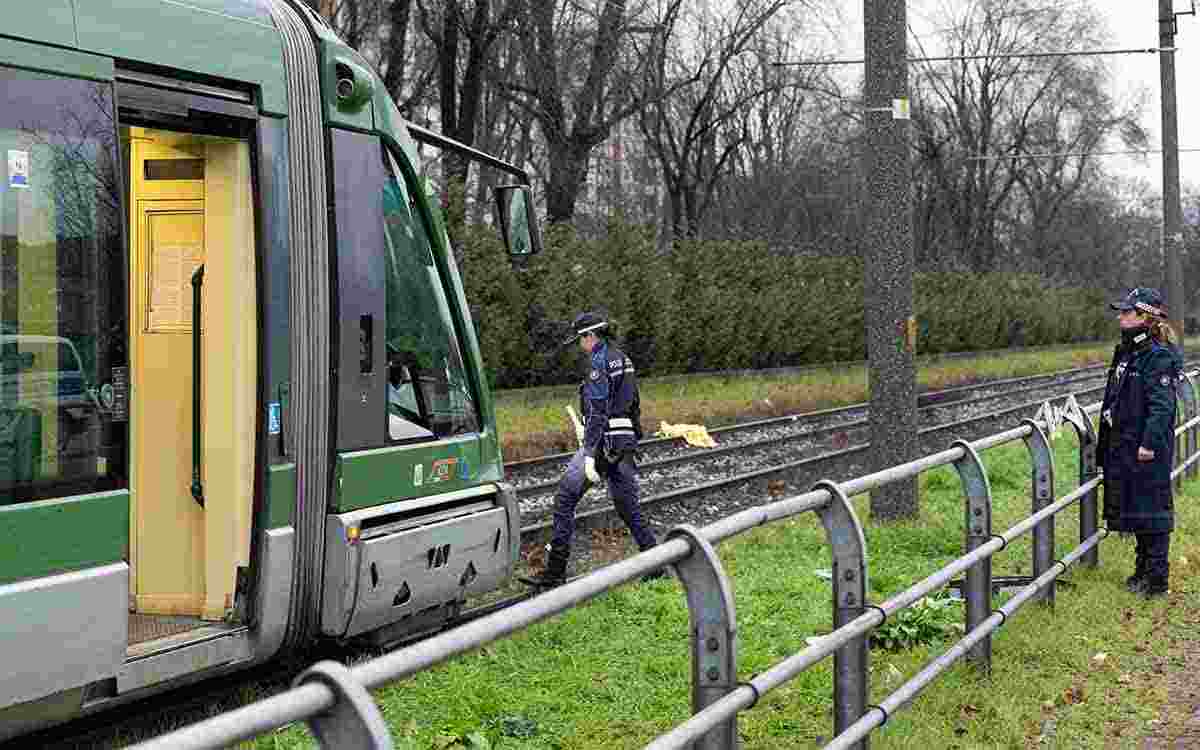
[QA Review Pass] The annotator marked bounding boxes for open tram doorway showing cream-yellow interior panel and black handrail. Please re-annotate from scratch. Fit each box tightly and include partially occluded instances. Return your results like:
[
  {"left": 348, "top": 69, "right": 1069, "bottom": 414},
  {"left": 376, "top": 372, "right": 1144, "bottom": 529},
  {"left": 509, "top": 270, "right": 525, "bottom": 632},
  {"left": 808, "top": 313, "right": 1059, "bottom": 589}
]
[{"left": 122, "top": 127, "right": 257, "bottom": 647}]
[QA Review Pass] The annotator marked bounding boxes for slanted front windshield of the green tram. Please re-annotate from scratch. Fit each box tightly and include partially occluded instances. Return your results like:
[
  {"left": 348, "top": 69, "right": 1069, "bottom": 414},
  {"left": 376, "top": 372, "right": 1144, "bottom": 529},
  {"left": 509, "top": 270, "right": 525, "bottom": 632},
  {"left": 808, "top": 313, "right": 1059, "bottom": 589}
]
[{"left": 383, "top": 150, "right": 479, "bottom": 440}]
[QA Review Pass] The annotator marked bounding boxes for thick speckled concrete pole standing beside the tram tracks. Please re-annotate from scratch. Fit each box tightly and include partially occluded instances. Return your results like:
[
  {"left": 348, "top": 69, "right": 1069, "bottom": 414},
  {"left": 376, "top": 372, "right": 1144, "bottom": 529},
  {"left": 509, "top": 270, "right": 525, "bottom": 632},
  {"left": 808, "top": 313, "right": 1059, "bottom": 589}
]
[{"left": 863, "top": 0, "right": 919, "bottom": 518}]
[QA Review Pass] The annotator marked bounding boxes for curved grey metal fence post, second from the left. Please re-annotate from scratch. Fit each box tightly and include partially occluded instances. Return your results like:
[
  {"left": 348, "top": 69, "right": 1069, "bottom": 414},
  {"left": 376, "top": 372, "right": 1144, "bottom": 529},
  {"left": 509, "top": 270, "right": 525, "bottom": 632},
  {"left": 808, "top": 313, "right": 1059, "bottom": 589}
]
[{"left": 667, "top": 524, "right": 738, "bottom": 750}]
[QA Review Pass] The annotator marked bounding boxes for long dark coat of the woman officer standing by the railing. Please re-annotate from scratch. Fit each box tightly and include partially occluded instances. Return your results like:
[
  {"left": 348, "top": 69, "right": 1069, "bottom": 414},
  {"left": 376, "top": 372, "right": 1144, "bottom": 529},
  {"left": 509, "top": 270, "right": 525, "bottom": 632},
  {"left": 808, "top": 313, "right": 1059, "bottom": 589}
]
[{"left": 1096, "top": 334, "right": 1181, "bottom": 533}]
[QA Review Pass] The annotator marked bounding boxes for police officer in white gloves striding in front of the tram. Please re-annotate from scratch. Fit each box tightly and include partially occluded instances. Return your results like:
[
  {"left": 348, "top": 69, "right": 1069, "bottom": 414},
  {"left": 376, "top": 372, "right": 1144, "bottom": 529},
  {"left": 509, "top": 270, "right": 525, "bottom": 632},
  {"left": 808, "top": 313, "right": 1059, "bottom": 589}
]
[{"left": 521, "top": 312, "right": 664, "bottom": 589}]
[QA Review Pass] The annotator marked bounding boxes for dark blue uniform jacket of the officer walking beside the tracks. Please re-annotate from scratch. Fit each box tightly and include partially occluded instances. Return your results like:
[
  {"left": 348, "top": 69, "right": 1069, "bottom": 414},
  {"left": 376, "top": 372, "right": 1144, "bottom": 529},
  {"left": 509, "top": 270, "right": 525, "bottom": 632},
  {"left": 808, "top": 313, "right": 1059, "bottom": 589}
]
[{"left": 580, "top": 341, "right": 642, "bottom": 456}]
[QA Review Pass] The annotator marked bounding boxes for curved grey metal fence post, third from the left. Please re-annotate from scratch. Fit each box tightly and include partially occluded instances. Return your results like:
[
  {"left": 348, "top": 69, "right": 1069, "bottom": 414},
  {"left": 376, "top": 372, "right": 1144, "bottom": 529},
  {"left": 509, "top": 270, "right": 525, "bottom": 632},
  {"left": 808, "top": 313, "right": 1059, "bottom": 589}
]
[{"left": 812, "top": 480, "right": 869, "bottom": 750}]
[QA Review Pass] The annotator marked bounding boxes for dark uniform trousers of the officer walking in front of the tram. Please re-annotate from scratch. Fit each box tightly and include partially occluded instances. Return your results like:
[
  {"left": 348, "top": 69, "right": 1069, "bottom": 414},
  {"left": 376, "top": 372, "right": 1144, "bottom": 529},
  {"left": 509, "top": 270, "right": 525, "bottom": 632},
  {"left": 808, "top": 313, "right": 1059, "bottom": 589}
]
[{"left": 550, "top": 448, "right": 655, "bottom": 551}]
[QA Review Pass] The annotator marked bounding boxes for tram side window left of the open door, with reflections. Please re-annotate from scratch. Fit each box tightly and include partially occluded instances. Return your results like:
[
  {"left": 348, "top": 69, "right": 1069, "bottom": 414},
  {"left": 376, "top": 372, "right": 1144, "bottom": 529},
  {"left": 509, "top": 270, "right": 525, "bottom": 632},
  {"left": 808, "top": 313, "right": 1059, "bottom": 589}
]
[{"left": 0, "top": 66, "right": 127, "bottom": 505}]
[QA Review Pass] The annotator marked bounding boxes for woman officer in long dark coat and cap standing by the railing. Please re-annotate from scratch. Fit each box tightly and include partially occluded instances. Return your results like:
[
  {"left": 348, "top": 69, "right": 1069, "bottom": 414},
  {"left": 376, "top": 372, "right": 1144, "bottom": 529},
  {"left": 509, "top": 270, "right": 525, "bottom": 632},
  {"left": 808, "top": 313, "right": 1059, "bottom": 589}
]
[{"left": 1096, "top": 287, "right": 1182, "bottom": 599}]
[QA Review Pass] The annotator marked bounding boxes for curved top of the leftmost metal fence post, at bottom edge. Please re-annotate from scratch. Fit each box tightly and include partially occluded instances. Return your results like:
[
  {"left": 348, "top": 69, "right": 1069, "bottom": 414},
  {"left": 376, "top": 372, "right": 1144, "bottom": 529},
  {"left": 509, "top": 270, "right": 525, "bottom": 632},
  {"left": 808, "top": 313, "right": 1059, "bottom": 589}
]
[{"left": 293, "top": 661, "right": 392, "bottom": 750}]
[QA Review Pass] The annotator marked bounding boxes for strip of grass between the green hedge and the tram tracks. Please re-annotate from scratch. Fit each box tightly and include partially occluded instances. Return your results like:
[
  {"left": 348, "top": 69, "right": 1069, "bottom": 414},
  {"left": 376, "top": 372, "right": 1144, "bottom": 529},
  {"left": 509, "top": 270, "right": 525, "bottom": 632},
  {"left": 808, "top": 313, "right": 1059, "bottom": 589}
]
[{"left": 496, "top": 342, "right": 1195, "bottom": 461}]
